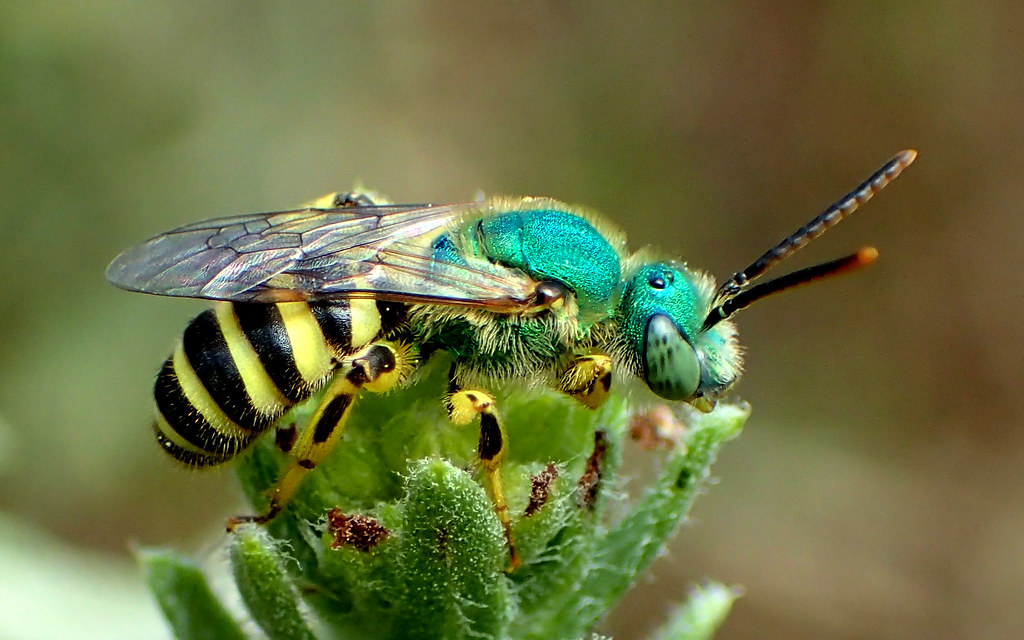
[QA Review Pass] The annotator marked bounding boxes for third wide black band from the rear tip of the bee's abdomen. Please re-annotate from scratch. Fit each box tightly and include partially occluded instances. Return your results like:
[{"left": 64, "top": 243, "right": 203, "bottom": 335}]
[{"left": 232, "top": 302, "right": 309, "bottom": 402}]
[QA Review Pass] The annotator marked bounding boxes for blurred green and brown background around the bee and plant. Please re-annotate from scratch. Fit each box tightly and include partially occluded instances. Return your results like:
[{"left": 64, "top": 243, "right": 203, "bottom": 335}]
[{"left": 0, "top": 0, "right": 1024, "bottom": 640}]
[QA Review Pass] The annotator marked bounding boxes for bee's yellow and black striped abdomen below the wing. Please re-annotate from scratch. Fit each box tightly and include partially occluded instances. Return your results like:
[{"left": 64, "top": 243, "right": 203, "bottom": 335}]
[{"left": 154, "top": 300, "right": 394, "bottom": 467}]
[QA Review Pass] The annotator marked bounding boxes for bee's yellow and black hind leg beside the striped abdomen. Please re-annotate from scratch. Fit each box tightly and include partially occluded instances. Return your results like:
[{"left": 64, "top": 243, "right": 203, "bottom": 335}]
[{"left": 227, "top": 342, "right": 411, "bottom": 531}]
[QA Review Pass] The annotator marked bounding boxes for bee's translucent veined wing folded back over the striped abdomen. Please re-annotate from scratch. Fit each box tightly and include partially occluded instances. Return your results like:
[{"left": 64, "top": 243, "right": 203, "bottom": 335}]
[{"left": 106, "top": 204, "right": 537, "bottom": 312}]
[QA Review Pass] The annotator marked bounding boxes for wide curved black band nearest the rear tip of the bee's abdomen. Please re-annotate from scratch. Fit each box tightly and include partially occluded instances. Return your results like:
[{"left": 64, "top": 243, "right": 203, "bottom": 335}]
[{"left": 153, "top": 357, "right": 253, "bottom": 460}]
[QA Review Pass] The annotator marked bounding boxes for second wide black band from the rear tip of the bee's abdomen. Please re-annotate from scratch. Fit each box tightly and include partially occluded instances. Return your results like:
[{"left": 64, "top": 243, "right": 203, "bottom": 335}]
[{"left": 181, "top": 309, "right": 274, "bottom": 432}]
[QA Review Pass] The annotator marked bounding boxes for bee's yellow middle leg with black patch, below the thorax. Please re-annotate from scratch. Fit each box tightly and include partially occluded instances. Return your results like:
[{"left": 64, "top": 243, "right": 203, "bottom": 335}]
[{"left": 446, "top": 368, "right": 522, "bottom": 571}]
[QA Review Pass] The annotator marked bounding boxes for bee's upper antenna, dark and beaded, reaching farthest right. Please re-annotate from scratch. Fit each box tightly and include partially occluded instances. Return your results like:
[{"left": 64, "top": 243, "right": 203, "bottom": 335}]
[{"left": 708, "top": 148, "right": 918, "bottom": 303}]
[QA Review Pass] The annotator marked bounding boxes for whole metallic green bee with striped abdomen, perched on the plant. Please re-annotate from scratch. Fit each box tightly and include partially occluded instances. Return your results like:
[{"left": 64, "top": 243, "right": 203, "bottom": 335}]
[{"left": 106, "top": 151, "right": 916, "bottom": 565}]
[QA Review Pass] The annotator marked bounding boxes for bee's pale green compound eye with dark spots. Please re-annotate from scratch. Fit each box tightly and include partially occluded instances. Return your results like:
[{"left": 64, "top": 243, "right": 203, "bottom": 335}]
[{"left": 643, "top": 313, "right": 700, "bottom": 400}]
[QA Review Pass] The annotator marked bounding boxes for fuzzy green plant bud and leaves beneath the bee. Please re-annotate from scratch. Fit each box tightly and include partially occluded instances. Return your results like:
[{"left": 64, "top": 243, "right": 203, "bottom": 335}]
[{"left": 141, "top": 362, "right": 749, "bottom": 640}]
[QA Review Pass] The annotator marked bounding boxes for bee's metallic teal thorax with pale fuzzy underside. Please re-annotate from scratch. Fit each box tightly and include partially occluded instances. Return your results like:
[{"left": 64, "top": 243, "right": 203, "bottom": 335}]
[{"left": 421, "top": 206, "right": 623, "bottom": 378}]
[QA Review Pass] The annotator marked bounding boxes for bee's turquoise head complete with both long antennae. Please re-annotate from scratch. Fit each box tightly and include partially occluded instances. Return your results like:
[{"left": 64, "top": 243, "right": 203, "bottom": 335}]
[{"left": 621, "top": 148, "right": 918, "bottom": 411}]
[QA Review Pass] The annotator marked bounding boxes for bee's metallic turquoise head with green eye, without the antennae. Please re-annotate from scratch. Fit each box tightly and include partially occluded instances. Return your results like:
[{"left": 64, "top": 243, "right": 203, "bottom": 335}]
[{"left": 622, "top": 262, "right": 742, "bottom": 409}]
